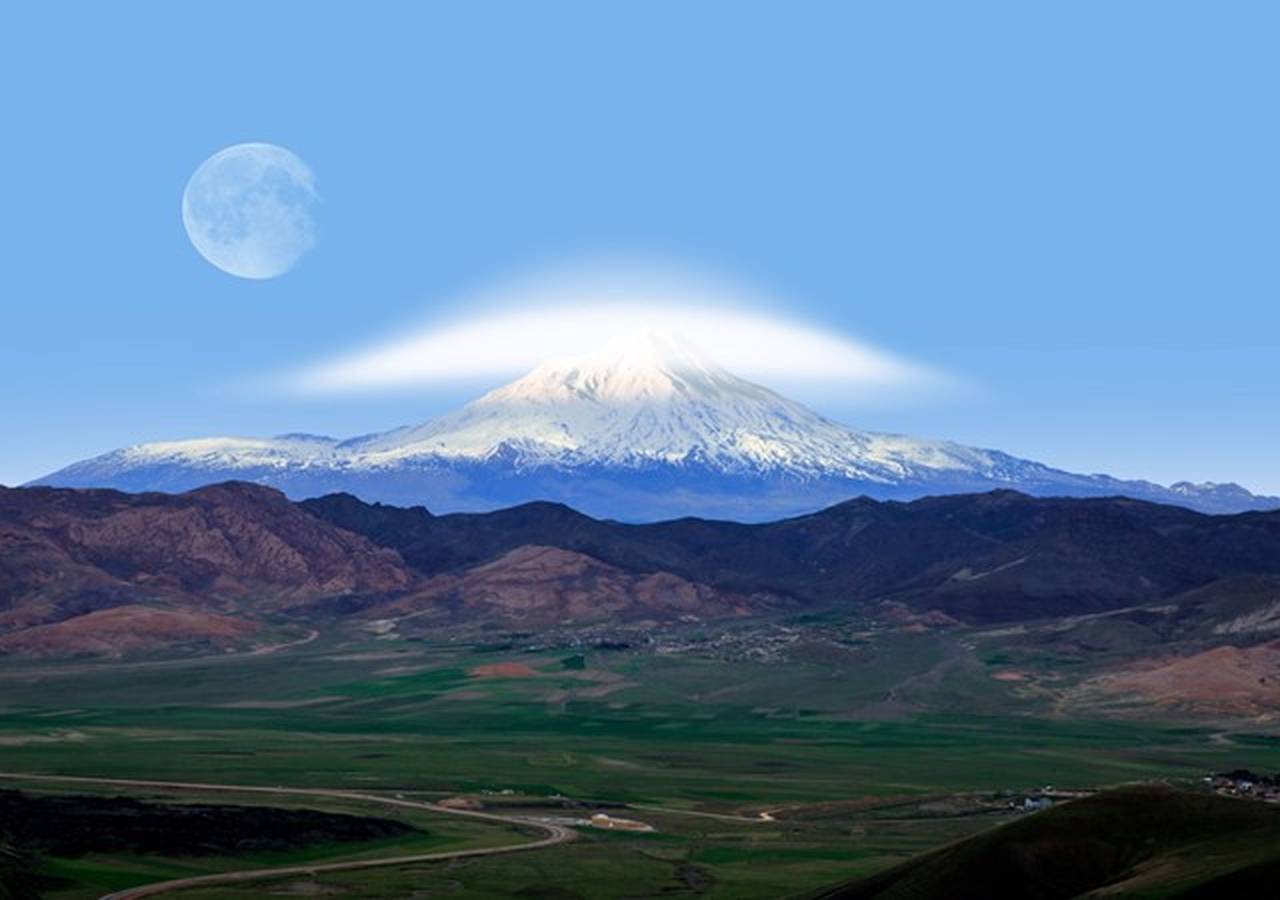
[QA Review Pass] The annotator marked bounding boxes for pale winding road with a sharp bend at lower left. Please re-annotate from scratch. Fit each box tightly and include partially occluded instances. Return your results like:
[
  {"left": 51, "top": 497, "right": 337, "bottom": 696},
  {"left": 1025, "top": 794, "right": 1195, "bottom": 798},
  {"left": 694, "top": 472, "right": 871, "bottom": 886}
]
[{"left": 0, "top": 772, "right": 577, "bottom": 900}]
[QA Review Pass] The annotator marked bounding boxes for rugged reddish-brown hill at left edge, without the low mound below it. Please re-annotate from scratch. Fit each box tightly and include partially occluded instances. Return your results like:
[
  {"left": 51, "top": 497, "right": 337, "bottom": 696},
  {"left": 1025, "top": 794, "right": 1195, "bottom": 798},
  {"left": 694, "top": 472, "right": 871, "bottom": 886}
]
[{"left": 0, "top": 484, "right": 413, "bottom": 606}]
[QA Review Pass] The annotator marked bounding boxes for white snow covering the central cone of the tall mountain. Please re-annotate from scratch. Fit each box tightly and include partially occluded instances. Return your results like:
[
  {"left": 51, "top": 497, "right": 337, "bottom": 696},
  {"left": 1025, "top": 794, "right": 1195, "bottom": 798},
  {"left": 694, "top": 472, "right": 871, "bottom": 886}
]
[{"left": 343, "top": 334, "right": 1018, "bottom": 481}]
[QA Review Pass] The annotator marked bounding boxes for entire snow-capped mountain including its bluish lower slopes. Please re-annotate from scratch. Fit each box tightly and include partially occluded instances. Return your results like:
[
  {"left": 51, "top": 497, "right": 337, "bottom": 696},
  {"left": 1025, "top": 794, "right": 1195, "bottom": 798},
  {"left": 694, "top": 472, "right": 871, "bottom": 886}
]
[{"left": 30, "top": 334, "right": 1280, "bottom": 520}]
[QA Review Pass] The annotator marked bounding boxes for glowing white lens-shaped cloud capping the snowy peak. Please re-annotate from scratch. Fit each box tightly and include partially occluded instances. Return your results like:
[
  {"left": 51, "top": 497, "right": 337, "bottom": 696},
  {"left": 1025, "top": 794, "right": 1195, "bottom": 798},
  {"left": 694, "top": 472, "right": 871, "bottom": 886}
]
[{"left": 284, "top": 262, "right": 952, "bottom": 394}]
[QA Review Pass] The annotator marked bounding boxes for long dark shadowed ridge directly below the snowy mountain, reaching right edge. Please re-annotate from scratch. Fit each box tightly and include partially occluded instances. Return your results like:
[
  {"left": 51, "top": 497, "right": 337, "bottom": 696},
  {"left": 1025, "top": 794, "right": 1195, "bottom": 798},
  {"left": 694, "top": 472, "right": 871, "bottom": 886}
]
[{"left": 302, "top": 490, "right": 1280, "bottom": 622}]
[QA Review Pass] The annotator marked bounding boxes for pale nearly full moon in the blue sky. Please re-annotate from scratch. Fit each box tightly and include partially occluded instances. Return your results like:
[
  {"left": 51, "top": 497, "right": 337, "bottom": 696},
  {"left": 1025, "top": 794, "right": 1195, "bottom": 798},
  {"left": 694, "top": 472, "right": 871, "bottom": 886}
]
[{"left": 182, "top": 143, "right": 320, "bottom": 279}]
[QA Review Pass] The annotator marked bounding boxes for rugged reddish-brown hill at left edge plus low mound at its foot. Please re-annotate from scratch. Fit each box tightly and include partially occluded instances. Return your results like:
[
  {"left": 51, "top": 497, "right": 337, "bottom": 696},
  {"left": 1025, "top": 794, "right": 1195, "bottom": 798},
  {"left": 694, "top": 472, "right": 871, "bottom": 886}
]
[{"left": 0, "top": 484, "right": 417, "bottom": 654}]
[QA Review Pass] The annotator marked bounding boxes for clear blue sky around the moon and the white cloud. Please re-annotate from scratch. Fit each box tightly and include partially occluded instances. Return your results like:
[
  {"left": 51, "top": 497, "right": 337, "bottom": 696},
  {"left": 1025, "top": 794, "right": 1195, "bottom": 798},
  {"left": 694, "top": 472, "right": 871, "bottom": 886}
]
[{"left": 0, "top": 3, "right": 1280, "bottom": 493}]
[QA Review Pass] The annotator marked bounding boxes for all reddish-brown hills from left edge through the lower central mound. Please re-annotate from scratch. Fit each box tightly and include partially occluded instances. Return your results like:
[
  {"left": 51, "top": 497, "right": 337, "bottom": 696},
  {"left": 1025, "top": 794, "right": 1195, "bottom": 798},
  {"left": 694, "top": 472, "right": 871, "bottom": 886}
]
[{"left": 0, "top": 483, "right": 757, "bottom": 655}]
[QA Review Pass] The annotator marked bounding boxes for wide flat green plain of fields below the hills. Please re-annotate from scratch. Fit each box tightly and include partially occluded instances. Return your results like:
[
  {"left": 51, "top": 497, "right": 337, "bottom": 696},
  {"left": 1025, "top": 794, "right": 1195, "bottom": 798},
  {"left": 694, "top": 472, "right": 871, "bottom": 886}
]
[{"left": 0, "top": 636, "right": 1280, "bottom": 897}]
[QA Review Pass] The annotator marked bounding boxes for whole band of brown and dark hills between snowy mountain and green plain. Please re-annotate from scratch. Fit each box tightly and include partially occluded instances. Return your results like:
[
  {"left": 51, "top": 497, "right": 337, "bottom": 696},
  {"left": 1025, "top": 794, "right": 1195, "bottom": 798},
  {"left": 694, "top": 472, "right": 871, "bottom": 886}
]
[{"left": 0, "top": 483, "right": 1280, "bottom": 654}]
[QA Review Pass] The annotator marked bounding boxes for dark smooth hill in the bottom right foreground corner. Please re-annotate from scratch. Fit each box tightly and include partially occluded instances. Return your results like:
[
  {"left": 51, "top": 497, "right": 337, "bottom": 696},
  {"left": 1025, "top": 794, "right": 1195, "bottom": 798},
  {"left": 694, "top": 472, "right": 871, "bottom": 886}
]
[{"left": 817, "top": 787, "right": 1280, "bottom": 900}]
